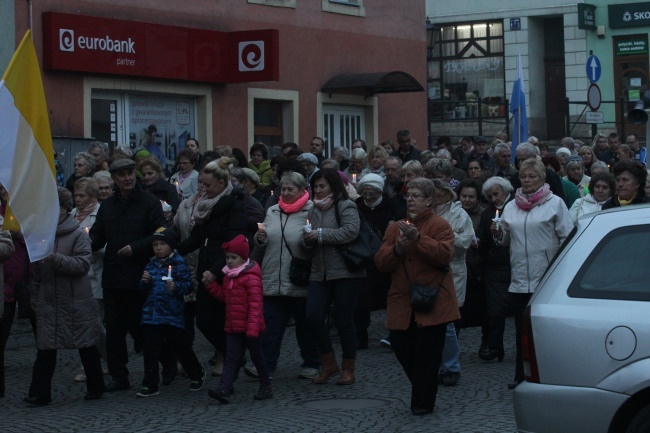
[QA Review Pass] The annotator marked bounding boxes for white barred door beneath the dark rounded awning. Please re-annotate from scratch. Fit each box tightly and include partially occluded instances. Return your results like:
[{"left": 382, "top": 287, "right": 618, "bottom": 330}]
[{"left": 323, "top": 105, "right": 366, "bottom": 155}]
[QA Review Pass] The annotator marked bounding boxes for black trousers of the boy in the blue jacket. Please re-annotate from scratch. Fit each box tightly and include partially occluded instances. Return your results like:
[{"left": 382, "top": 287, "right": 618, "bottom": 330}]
[{"left": 142, "top": 325, "right": 203, "bottom": 390}]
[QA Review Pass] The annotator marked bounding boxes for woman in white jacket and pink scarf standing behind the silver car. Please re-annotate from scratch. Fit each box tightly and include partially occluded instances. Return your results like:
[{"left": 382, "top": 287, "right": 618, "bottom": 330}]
[{"left": 491, "top": 158, "right": 573, "bottom": 389}]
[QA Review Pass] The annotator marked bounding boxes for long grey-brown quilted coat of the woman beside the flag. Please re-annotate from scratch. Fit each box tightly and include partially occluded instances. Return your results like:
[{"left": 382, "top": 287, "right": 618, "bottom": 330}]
[{"left": 31, "top": 215, "right": 101, "bottom": 350}]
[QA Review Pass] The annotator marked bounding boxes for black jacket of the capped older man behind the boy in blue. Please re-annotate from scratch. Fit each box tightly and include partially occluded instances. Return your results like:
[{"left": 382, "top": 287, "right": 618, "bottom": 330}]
[{"left": 90, "top": 186, "right": 165, "bottom": 290}]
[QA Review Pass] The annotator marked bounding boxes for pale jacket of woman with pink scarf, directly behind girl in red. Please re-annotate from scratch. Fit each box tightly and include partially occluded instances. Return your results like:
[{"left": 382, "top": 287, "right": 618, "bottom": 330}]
[{"left": 255, "top": 200, "right": 314, "bottom": 297}]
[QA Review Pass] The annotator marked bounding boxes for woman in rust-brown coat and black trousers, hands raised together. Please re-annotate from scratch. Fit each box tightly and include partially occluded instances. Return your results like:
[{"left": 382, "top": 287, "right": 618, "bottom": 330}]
[{"left": 375, "top": 178, "right": 460, "bottom": 415}]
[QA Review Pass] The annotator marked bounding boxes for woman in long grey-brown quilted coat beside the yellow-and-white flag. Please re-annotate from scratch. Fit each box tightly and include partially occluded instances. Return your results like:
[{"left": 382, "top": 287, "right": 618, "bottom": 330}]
[{"left": 23, "top": 188, "right": 105, "bottom": 406}]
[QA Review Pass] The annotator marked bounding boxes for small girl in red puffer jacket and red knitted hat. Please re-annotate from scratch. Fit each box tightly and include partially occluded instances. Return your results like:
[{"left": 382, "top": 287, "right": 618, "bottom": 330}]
[{"left": 206, "top": 235, "right": 273, "bottom": 403}]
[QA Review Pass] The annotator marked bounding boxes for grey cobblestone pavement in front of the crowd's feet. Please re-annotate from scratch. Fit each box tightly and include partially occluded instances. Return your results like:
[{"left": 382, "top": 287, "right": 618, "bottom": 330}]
[{"left": 0, "top": 314, "right": 516, "bottom": 433}]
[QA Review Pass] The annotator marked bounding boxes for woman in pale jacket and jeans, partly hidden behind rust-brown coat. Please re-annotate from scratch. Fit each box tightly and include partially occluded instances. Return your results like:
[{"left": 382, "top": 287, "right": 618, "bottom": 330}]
[{"left": 433, "top": 179, "right": 474, "bottom": 386}]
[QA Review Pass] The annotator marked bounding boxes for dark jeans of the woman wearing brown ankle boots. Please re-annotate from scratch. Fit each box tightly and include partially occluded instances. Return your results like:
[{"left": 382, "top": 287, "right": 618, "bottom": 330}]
[{"left": 306, "top": 278, "right": 363, "bottom": 359}]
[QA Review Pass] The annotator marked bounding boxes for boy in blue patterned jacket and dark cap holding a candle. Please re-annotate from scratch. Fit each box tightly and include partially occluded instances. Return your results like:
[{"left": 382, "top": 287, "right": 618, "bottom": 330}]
[{"left": 136, "top": 227, "right": 205, "bottom": 397}]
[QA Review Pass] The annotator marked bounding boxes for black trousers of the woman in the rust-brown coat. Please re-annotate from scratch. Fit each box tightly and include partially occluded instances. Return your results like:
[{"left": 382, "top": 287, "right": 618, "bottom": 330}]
[{"left": 390, "top": 317, "right": 447, "bottom": 410}]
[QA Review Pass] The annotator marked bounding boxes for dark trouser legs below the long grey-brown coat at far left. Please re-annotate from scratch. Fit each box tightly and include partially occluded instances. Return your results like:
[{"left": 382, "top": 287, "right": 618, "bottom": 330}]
[{"left": 29, "top": 346, "right": 105, "bottom": 402}]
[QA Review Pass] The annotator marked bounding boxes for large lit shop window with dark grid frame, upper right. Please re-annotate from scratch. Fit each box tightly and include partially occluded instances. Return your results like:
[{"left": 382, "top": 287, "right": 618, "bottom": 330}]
[{"left": 427, "top": 21, "right": 505, "bottom": 119}]
